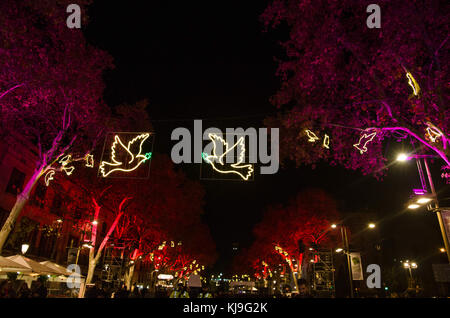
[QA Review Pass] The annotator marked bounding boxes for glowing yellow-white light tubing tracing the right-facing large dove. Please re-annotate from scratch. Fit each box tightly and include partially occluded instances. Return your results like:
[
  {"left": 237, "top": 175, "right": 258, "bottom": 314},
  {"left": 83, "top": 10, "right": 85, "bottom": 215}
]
[{"left": 100, "top": 133, "right": 151, "bottom": 178}]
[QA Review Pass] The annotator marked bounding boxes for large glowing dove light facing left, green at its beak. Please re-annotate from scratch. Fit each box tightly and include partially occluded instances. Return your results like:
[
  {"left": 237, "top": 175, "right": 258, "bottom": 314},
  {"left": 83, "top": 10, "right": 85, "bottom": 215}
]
[{"left": 203, "top": 134, "right": 253, "bottom": 180}]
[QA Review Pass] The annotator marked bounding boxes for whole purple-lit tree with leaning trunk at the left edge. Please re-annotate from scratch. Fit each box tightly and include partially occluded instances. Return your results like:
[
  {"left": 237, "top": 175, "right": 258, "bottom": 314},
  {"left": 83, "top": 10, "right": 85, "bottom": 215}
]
[{"left": 0, "top": 0, "right": 112, "bottom": 251}]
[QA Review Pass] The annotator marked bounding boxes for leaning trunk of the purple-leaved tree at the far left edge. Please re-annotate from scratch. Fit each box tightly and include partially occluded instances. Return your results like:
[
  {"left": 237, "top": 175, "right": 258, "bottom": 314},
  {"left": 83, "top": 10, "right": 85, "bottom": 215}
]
[{"left": 0, "top": 166, "right": 44, "bottom": 255}]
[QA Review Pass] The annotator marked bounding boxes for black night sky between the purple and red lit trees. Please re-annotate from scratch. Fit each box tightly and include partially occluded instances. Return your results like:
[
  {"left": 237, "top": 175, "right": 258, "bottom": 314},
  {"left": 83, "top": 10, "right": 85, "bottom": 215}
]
[{"left": 86, "top": 0, "right": 442, "bottom": 271}]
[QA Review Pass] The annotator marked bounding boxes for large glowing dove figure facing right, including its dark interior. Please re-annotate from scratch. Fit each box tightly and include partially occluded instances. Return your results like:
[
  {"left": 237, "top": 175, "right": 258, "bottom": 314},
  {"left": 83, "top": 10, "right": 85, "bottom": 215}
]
[{"left": 100, "top": 133, "right": 151, "bottom": 178}]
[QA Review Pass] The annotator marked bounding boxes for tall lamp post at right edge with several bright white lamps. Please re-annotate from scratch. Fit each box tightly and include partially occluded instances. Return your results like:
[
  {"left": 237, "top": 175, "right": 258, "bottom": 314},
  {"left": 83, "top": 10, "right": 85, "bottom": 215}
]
[{"left": 397, "top": 154, "right": 450, "bottom": 263}]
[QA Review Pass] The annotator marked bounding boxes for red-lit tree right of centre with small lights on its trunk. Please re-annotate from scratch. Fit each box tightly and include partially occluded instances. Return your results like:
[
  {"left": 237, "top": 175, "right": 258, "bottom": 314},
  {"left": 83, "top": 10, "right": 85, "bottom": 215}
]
[{"left": 241, "top": 189, "right": 338, "bottom": 284}]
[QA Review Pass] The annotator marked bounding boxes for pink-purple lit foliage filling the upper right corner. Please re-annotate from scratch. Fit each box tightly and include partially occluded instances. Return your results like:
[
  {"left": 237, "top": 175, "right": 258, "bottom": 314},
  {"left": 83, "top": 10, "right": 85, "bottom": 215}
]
[{"left": 261, "top": 0, "right": 450, "bottom": 178}]
